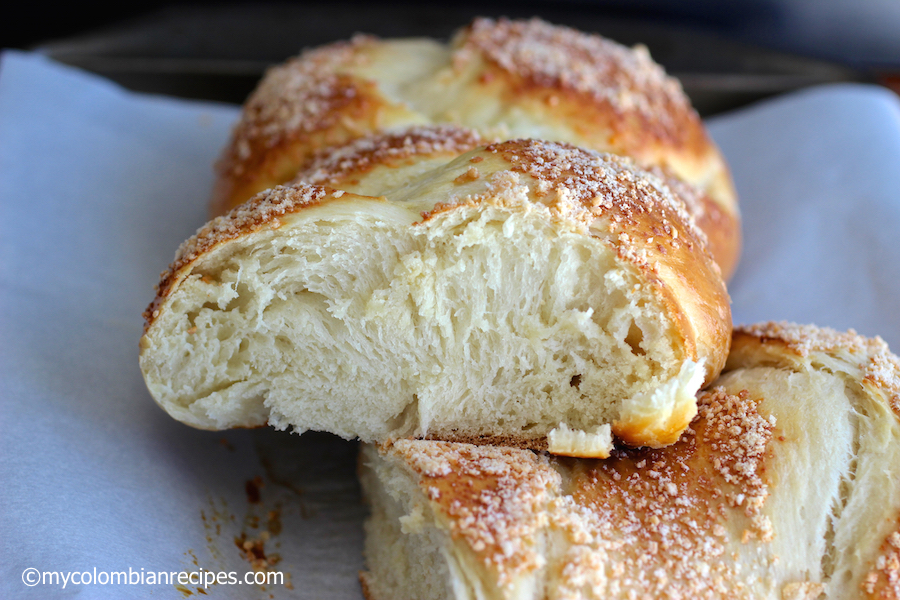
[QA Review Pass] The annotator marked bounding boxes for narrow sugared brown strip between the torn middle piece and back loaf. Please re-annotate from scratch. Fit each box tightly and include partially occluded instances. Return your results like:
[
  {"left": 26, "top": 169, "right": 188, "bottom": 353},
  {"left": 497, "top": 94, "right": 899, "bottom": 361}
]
[{"left": 295, "top": 125, "right": 484, "bottom": 185}]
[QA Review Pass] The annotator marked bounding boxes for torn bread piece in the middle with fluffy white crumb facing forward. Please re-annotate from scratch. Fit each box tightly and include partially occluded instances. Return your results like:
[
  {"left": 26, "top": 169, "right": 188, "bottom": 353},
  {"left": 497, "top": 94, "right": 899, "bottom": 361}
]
[{"left": 140, "top": 133, "right": 731, "bottom": 456}]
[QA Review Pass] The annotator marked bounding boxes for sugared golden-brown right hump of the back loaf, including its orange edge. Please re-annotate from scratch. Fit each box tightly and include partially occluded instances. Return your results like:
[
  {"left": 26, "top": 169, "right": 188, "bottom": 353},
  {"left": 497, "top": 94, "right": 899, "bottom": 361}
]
[{"left": 454, "top": 18, "right": 710, "bottom": 164}]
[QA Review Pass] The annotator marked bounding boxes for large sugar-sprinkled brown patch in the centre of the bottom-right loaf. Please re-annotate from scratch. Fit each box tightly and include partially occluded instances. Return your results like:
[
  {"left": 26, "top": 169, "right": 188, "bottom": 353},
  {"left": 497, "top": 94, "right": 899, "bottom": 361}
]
[{"left": 393, "top": 389, "right": 774, "bottom": 599}]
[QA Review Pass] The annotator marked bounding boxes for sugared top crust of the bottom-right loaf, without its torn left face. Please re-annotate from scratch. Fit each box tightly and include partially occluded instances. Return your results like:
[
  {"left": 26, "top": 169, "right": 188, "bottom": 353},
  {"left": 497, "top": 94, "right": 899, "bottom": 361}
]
[{"left": 364, "top": 323, "right": 900, "bottom": 600}]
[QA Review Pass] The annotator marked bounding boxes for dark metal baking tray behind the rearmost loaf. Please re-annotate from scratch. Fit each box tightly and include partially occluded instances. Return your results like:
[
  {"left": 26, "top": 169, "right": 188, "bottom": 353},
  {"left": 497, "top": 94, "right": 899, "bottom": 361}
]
[{"left": 39, "top": 2, "right": 874, "bottom": 116}]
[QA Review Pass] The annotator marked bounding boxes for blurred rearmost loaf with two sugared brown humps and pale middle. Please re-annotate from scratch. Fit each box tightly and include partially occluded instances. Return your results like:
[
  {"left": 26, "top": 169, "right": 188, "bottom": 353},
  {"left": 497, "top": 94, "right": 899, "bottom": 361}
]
[{"left": 211, "top": 19, "right": 740, "bottom": 277}]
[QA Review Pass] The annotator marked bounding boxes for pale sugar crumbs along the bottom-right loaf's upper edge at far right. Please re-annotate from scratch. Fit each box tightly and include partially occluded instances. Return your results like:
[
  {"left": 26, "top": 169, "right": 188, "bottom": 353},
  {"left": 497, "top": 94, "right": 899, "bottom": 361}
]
[{"left": 735, "top": 321, "right": 900, "bottom": 417}]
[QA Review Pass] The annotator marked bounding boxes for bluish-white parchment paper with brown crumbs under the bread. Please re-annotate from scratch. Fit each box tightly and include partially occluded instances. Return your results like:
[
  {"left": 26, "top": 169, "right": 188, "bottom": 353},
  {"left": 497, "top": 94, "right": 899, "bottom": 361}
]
[{"left": 0, "top": 52, "right": 900, "bottom": 600}]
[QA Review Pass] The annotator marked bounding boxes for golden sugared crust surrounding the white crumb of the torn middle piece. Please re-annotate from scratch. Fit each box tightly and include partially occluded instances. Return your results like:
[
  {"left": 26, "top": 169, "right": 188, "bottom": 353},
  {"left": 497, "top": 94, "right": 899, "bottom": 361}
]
[{"left": 141, "top": 138, "right": 731, "bottom": 448}]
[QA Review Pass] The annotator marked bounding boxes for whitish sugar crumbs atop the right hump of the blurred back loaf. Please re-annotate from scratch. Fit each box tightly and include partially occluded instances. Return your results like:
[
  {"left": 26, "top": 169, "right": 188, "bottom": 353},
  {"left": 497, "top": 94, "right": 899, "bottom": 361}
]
[{"left": 457, "top": 18, "right": 699, "bottom": 140}]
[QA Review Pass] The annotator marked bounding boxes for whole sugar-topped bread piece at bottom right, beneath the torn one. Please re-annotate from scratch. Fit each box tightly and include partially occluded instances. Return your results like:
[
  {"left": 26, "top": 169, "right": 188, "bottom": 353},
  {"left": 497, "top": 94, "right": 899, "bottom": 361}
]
[{"left": 361, "top": 324, "right": 900, "bottom": 600}]
